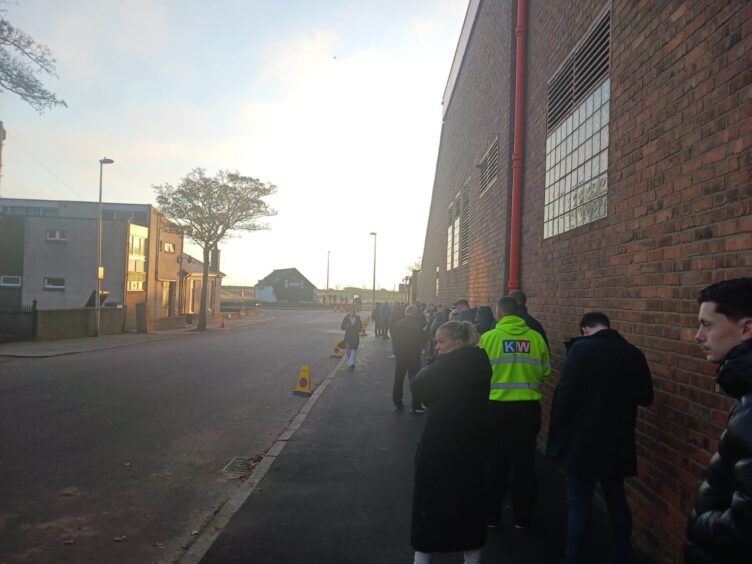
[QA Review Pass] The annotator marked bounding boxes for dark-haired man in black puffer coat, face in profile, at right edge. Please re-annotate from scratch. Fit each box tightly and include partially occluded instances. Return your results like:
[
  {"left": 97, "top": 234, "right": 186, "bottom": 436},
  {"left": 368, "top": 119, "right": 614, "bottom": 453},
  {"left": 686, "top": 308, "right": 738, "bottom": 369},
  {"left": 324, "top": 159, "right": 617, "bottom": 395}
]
[{"left": 684, "top": 278, "right": 752, "bottom": 564}]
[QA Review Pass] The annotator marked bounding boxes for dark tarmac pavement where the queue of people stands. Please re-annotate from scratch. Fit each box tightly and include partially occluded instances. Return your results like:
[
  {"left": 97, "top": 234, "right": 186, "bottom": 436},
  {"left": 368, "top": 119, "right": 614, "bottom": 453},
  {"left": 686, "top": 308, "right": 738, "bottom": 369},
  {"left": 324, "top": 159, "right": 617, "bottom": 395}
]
[{"left": 185, "top": 333, "right": 652, "bottom": 564}]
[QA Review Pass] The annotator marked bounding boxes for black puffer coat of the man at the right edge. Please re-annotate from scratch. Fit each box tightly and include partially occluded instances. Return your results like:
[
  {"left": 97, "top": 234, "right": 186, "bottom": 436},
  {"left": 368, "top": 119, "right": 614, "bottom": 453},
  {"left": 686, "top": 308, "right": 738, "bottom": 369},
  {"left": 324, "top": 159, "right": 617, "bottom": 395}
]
[{"left": 685, "top": 340, "right": 752, "bottom": 564}]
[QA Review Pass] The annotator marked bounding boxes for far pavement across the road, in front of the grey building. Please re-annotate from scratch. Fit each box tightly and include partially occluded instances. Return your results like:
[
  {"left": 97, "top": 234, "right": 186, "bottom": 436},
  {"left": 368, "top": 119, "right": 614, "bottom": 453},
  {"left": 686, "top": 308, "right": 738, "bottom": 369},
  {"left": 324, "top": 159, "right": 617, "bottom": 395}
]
[{"left": 0, "top": 314, "right": 273, "bottom": 358}]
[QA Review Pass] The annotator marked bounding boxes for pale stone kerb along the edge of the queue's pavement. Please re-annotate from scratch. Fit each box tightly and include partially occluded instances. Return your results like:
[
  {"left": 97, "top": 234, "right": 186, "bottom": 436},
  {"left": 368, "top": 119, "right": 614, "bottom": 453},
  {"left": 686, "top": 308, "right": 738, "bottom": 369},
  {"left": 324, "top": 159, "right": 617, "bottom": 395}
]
[{"left": 179, "top": 358, "right": 345, "bottom": 564}]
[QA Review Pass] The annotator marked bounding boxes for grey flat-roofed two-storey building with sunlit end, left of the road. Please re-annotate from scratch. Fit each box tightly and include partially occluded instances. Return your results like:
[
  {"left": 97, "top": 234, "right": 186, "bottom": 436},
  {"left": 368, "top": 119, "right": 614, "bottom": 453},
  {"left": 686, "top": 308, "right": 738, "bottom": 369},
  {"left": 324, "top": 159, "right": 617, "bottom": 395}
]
[{"left": 0, "top": 198, "right": 188, "bottom": 329}]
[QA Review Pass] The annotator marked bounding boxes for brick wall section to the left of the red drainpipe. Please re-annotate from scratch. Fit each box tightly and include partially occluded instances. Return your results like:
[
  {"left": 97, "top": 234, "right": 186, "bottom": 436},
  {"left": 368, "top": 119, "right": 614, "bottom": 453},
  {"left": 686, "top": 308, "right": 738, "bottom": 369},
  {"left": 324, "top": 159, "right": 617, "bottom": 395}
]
[{"left": 418, "top": 2, "right": 514, "bottom": 304}]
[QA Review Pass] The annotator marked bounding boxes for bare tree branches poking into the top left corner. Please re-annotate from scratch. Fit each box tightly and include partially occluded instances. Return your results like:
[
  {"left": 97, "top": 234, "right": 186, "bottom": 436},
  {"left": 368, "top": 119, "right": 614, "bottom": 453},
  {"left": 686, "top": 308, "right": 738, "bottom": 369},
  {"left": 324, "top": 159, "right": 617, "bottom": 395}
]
[{"left": 0, "top": 2, "right": 67, "bottom": 114}]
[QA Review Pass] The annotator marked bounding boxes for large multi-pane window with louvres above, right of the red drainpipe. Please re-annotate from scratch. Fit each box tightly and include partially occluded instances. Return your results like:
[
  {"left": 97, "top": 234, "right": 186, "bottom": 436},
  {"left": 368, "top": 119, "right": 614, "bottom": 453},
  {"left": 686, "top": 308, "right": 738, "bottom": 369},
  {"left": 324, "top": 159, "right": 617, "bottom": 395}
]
[{"left": 543, "top": 12, "right": 611, "bottom": 238}]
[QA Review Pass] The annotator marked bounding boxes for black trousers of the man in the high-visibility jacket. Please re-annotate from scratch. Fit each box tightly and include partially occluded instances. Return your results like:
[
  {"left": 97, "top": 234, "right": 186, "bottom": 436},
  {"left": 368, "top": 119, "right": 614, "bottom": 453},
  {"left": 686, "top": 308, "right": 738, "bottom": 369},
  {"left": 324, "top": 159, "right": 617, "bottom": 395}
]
[{"left": 486, "top": 401, "right": 540, "bottom": 527}]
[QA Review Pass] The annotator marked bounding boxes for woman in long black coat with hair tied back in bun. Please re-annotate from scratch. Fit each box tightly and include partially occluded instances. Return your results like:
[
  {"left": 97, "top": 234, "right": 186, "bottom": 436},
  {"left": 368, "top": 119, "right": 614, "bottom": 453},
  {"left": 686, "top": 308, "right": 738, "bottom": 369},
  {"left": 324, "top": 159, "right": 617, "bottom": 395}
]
[{"left": 410, "top": 321, "right": 491, "bottom": 564}]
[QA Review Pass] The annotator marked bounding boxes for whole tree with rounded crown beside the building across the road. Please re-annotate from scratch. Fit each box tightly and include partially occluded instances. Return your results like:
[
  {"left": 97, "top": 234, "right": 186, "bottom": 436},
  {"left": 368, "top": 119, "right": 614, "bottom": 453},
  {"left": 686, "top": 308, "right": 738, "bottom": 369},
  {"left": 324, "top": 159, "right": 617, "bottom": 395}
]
[{"left": 153, "top": 168, "right": 277, "bottom": 330}]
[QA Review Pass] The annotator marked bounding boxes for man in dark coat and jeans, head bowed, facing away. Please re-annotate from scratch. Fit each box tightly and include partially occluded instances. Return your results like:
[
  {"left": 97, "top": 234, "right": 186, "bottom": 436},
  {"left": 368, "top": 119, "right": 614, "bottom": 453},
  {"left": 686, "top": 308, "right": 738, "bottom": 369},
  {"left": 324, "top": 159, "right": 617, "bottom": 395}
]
[{"left": 546, "top": 312, "right": 653, "bottom": 564}]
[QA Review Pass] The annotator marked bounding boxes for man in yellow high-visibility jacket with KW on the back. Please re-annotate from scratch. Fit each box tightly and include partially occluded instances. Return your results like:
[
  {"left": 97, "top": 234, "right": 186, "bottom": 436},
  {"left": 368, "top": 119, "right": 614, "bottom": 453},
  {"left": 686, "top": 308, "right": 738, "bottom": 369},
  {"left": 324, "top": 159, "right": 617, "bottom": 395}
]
[{"left": 480, "top": 297, "right": 551, "bottom": 529}]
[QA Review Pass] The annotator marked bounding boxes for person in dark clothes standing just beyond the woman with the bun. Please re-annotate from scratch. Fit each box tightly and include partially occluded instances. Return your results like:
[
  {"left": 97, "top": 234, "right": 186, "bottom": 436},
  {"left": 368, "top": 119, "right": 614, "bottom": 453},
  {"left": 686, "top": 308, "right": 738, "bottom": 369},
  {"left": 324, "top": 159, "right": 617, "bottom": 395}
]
[{"left": 391, "top": 304, "right": 428, "bottom": 414}]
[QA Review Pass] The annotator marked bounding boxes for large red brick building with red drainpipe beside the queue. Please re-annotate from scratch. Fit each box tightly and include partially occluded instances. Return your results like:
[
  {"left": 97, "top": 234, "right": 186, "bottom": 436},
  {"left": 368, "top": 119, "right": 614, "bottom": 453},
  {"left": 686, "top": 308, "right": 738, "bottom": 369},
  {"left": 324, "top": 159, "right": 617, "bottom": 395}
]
[{"left": 417, "top": 0, "right": 752, "bottom": 562}]
